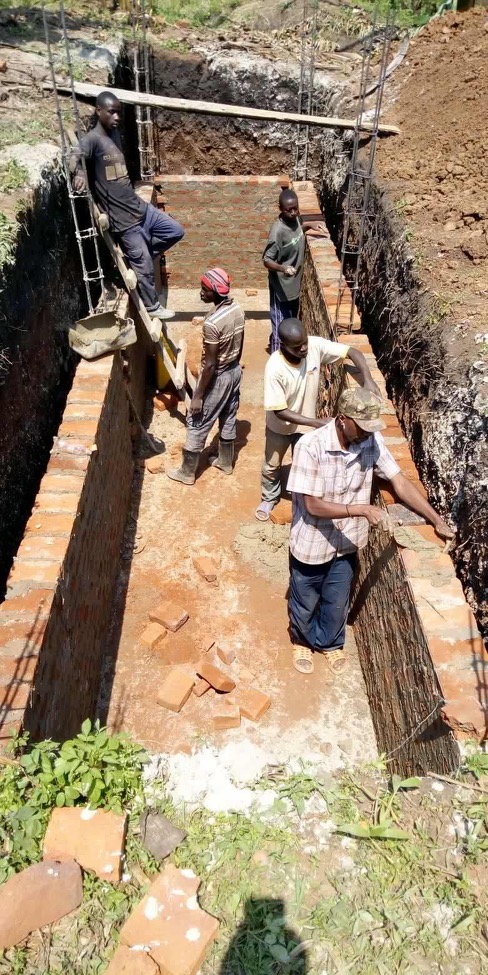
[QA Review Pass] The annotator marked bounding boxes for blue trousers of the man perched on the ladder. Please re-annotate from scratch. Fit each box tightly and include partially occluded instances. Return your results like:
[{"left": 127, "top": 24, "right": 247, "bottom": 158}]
[{"left": 118, "top": 203, "right": 185, "bottom": 311}]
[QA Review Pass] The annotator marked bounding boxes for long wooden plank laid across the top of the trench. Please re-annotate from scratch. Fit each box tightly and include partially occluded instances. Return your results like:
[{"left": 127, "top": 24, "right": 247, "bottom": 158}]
[{"left": 50, "top": 81, "right": 400, "bottom": 135}]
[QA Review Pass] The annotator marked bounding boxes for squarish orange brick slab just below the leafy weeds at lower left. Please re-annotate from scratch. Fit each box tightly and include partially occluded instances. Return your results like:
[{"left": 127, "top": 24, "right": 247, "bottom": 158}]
[{"left": 43, "top": 806, "right": 127, "bottom": 884}]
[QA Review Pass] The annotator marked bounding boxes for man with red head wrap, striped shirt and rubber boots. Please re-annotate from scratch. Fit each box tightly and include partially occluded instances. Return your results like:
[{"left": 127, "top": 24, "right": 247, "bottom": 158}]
[{"left": 168, "top": 267, "right": 244, "bottom": 484}]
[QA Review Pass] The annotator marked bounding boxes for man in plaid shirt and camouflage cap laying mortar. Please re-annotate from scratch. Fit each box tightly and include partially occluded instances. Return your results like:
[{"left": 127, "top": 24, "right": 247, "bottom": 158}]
[{"left": 288, "top": 387, "right": 454, "bottom": 674}]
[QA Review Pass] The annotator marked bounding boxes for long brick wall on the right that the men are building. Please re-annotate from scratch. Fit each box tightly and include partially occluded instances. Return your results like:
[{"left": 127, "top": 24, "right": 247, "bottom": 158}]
[{"left": 295, "top": 183, "right": 488, "bottom": 774}]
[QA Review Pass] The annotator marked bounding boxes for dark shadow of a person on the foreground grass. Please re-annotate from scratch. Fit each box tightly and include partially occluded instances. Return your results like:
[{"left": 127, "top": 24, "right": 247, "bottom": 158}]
[{"left": 219, "top": 897, "right": 309, "bottom": 975}]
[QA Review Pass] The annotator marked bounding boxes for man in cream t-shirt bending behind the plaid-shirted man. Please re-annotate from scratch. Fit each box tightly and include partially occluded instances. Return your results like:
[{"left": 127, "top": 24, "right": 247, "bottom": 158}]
[{"left": 256, "top": 318, "right": 380, "bottom": 521}]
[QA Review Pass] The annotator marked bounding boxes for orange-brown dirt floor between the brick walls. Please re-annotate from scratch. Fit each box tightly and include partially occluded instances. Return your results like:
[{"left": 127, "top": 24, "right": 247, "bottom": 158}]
[{"left": 101, "top": 292, "right": 375, "bottom": 768}]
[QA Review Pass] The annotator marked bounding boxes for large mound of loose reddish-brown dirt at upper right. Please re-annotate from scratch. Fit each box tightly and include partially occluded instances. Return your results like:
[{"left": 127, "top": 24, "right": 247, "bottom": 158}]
[{"left": 377, "top": 8, "right": 488, "bottom": 356}]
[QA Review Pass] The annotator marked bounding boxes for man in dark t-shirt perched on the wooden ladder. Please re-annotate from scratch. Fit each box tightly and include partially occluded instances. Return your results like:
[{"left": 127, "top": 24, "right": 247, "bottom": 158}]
[{"left": 70, "top": 91, "right": 185, "bottom": 319}]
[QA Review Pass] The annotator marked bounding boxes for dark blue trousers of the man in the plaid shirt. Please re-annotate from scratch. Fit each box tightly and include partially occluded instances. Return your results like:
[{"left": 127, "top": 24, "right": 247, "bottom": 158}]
[{"left": 288, "top": 552, "right": 357, "bottom": 650}]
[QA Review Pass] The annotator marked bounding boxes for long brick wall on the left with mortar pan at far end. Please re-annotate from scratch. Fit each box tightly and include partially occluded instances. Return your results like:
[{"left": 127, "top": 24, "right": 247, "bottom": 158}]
[{"left": 0, "top": 312, "right": 146, "bottom": 745}]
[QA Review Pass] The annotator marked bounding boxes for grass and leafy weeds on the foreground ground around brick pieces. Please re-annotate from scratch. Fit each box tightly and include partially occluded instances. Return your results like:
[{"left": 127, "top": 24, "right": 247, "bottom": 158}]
[{"left": 0, "top": 721, "right": 488, "bottom": 975}]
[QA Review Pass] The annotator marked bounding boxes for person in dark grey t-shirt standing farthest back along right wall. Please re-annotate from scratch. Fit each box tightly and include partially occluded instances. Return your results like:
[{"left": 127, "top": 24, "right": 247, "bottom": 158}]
[{"left": 263, "top": 189, "right": 325, "bottom": 352}]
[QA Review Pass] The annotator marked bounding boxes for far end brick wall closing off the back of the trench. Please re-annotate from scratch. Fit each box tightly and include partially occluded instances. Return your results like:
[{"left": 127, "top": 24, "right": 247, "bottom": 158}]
[{"left": 160, "top": 176, "right": 289, "bottom": 288}]
